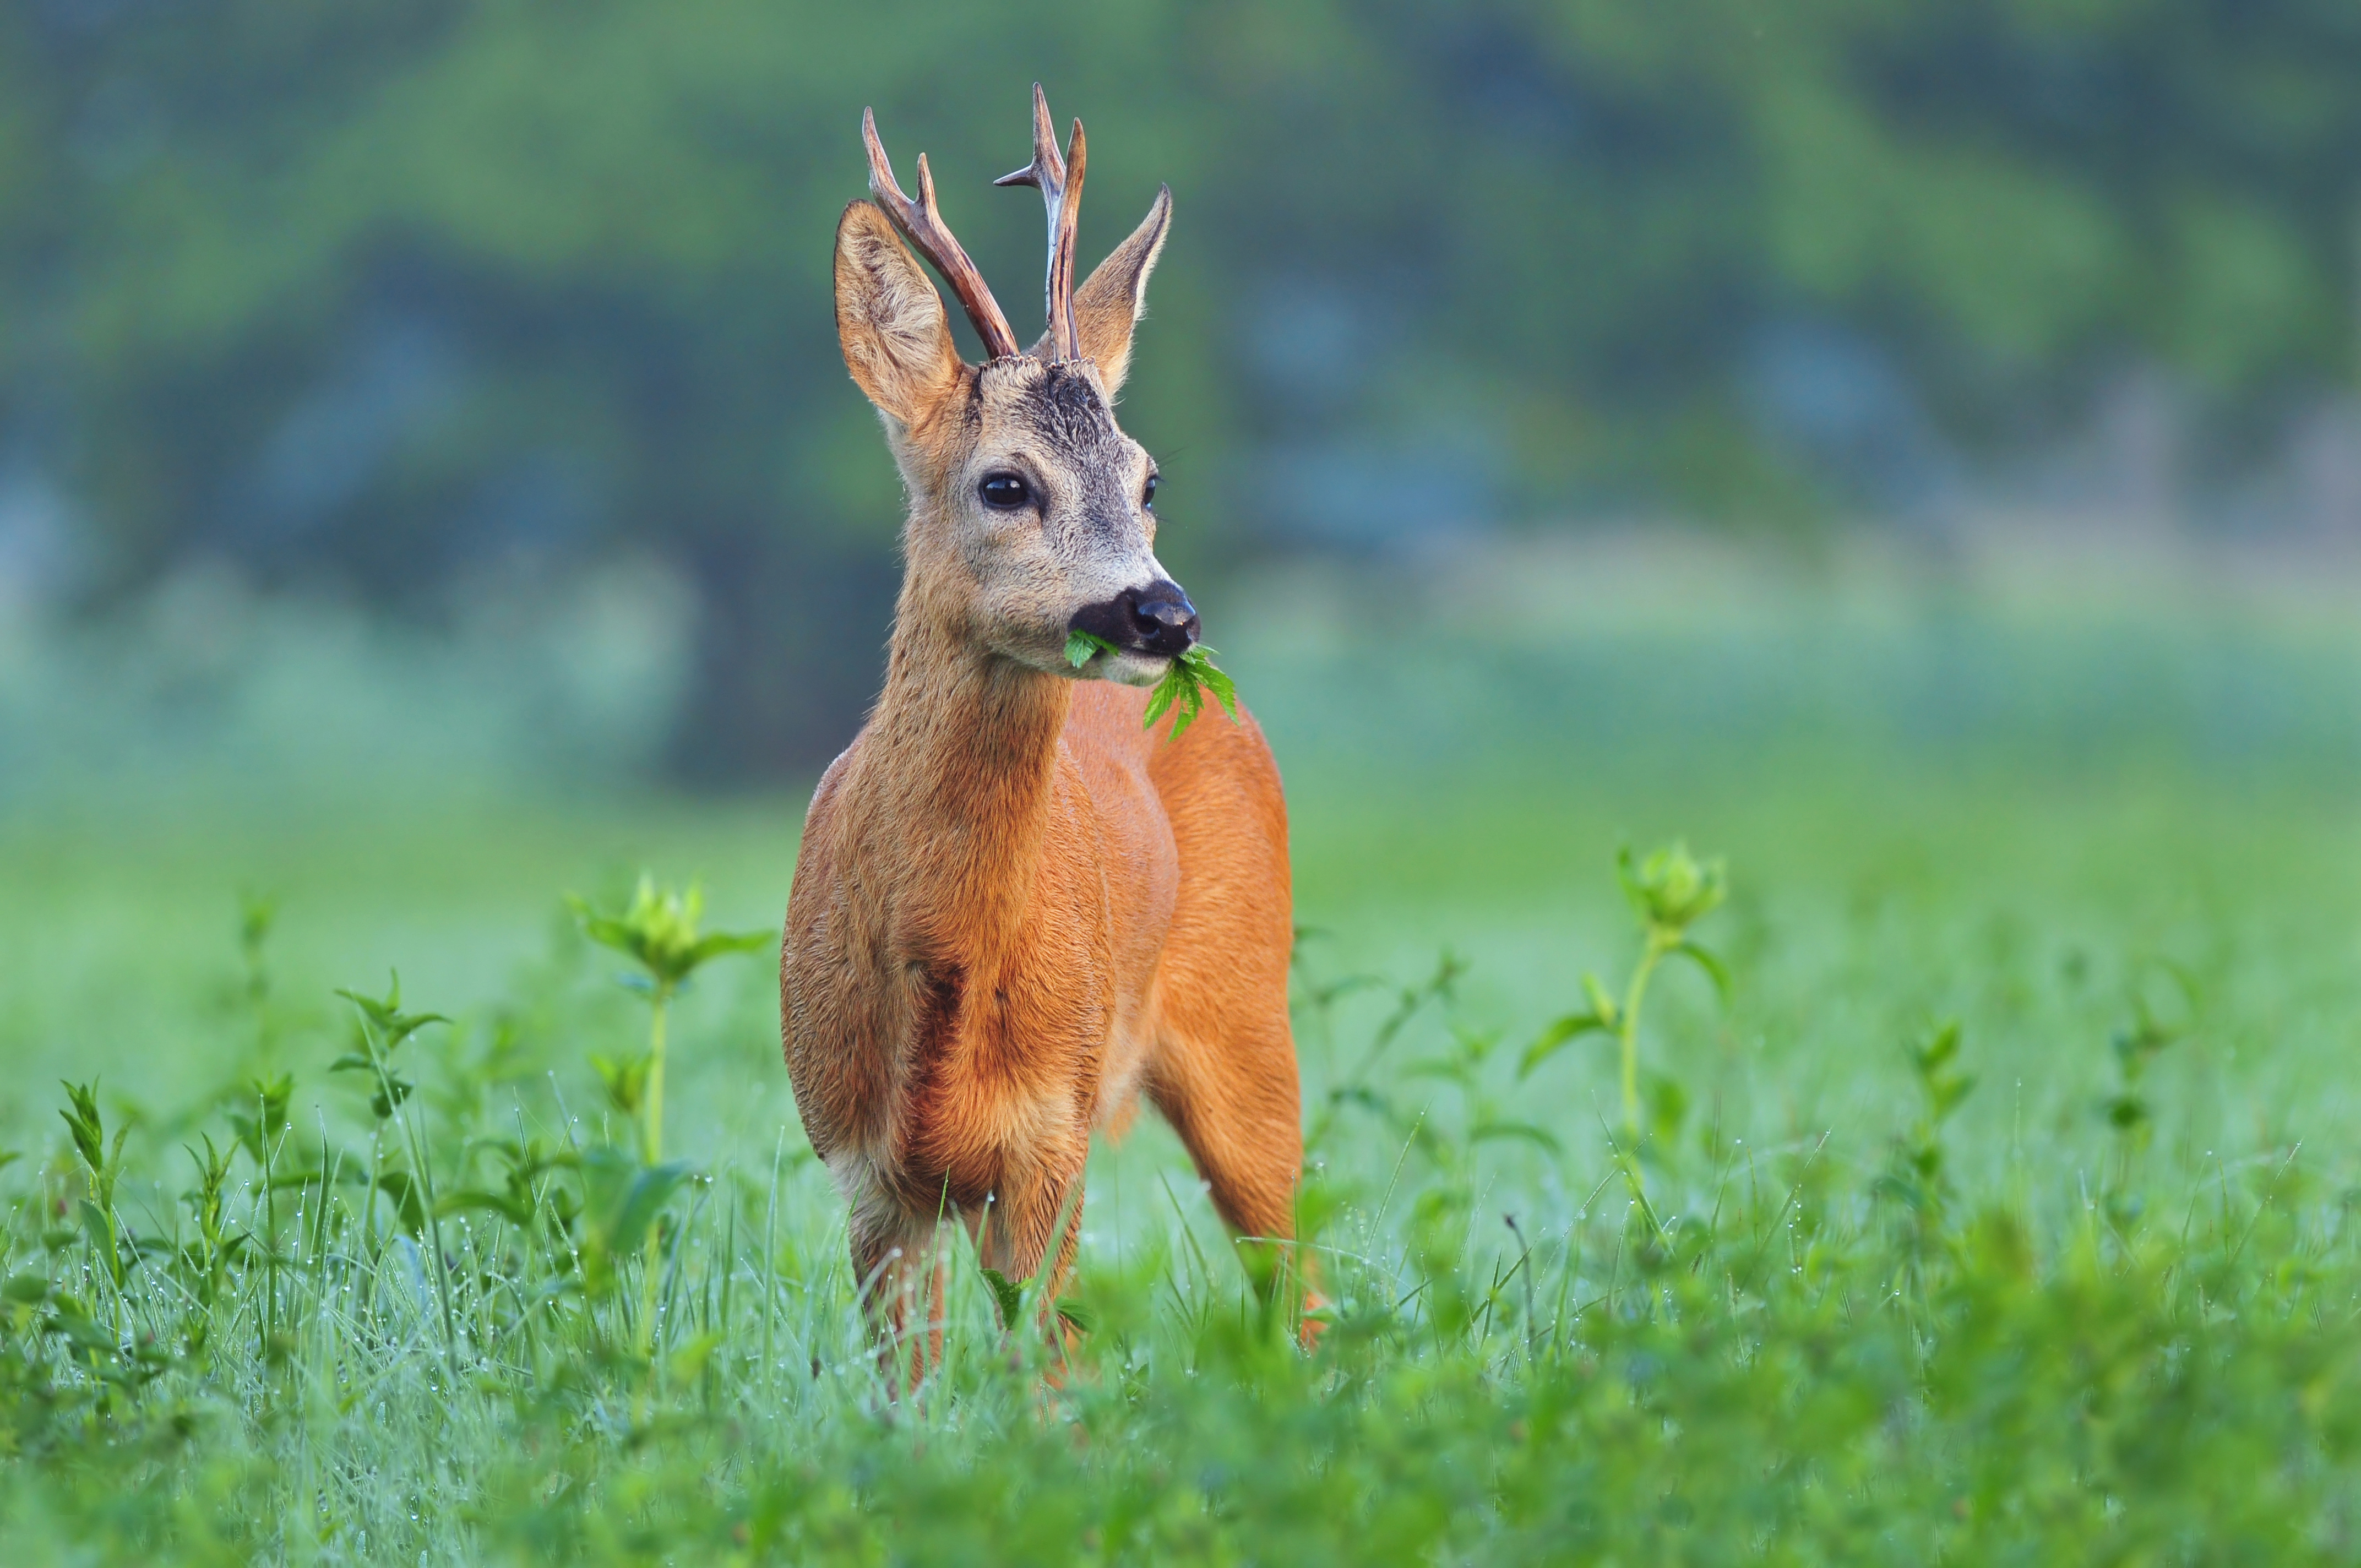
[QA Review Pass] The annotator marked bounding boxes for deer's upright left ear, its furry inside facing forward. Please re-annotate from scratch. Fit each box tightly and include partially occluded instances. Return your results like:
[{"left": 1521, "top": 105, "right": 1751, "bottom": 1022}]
[{"left": 836, "top": 201, "right": 959, "bottom": 425}]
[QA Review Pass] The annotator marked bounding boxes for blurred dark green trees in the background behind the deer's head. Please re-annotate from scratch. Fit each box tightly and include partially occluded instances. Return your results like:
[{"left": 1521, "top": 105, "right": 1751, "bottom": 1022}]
[{"left": 0, "top": 0, "right": 2361, "bottom": 777}]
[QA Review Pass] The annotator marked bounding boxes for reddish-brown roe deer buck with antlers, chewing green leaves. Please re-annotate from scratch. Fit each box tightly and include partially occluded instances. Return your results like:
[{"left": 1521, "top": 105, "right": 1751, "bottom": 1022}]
[{"left": 779, "top": 83, "right": 1318, "bottom": 1372}]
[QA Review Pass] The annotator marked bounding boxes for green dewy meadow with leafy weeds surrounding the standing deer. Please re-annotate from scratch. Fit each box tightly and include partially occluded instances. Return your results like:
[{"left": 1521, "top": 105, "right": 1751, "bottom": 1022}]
[{"left": 0, "top": 545, "right": 2361, "bottom": 1563}]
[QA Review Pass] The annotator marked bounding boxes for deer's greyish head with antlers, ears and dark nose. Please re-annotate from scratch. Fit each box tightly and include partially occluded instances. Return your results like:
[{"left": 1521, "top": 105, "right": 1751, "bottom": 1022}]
[{"left": 836, "top": 85, "right": 1197, "bottom": 685}]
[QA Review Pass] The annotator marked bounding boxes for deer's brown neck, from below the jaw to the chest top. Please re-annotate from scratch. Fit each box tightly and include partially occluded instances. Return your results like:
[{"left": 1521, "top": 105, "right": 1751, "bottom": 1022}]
[{"left": 869, "top": 600, "right": 1072, "bottom": 963}]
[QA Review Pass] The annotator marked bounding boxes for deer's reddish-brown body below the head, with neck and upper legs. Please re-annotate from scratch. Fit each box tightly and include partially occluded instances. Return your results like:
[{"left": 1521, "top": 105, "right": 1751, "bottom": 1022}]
[{"left": 781, "top": 595, "right": 1301, "bottom": 1322}]
